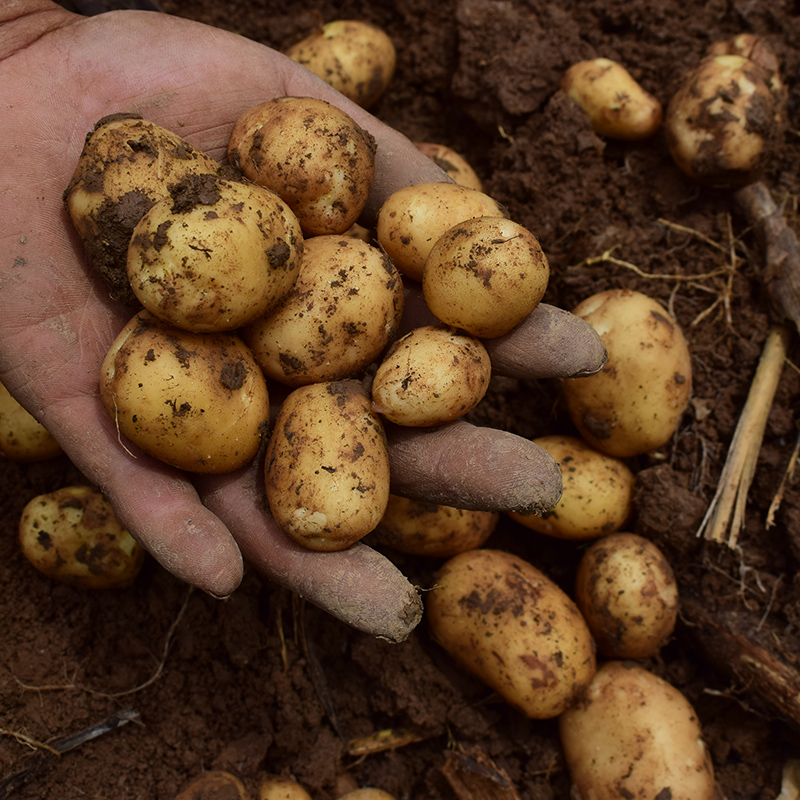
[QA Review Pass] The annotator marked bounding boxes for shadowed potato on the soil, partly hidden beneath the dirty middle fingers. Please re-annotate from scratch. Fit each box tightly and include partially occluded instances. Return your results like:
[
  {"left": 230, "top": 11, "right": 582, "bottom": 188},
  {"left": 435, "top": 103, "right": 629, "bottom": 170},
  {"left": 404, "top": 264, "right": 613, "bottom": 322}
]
[{"left": 370, "top": 494, "right": 500, "bottom": 558}]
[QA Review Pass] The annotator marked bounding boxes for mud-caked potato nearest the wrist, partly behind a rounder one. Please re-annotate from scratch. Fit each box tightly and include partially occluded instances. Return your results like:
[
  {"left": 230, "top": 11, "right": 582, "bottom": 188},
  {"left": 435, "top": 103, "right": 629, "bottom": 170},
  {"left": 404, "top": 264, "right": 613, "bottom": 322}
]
[{"left": 64, "top": 113, "right": 219, "bottom": 307}]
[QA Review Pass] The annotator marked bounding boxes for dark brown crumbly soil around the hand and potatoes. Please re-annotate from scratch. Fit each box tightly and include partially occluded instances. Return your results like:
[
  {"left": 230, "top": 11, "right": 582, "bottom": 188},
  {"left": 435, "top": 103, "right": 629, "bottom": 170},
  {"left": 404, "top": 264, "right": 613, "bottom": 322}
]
[{"left": 0, "top": 0, "right": 800, "bottom": 800}]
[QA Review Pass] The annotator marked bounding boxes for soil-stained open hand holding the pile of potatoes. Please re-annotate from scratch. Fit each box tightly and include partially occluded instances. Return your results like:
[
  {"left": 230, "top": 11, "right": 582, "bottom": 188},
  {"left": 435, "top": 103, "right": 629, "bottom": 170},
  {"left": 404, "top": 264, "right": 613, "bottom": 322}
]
[{"left": 0, "top": 0, "right": 604, "bottom": 641}]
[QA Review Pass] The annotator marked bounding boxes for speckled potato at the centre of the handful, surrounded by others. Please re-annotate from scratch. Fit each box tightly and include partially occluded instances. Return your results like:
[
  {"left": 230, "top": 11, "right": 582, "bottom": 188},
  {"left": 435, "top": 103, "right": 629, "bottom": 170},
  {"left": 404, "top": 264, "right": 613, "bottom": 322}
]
[{"left": 242, "top": 235, "right": 404, "bottom": 386}]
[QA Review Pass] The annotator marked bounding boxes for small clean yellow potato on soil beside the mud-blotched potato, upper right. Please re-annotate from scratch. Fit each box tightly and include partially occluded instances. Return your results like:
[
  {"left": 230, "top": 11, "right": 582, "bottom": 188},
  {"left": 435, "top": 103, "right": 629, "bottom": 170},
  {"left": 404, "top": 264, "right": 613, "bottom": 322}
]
[{"left": 561, "top": 58, "right": 663, "bottom": 141}]
